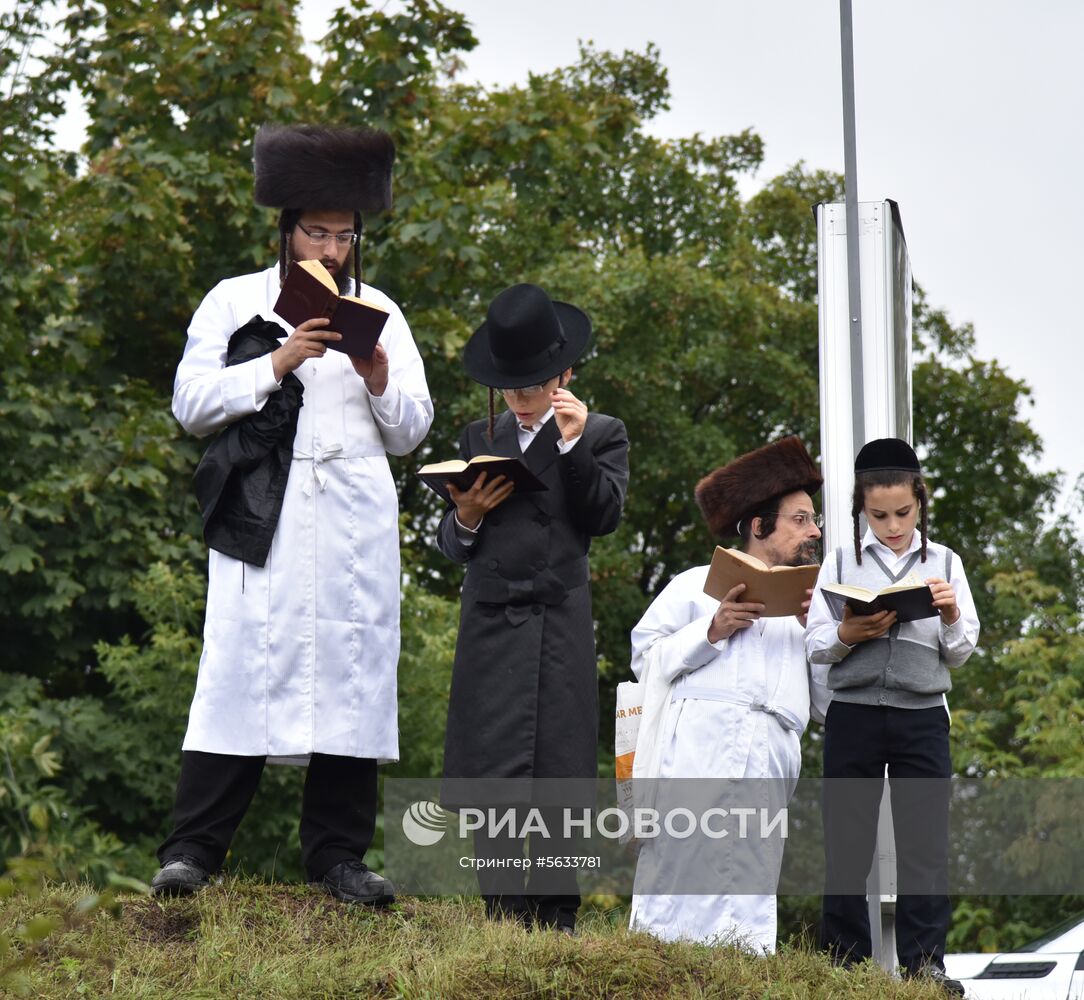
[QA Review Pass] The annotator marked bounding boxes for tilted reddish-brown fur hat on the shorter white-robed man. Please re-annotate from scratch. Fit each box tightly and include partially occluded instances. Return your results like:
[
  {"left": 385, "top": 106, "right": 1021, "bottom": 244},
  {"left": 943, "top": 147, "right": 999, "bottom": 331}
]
[{"left": 695, "top": 436, "right": 824, "bottom": 538}]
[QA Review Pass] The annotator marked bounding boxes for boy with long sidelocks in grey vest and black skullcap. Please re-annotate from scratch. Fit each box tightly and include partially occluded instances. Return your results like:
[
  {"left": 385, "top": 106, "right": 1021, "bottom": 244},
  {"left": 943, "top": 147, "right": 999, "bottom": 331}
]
[{"left": 805, "top": 438, "right": 979, "bottom": 995}]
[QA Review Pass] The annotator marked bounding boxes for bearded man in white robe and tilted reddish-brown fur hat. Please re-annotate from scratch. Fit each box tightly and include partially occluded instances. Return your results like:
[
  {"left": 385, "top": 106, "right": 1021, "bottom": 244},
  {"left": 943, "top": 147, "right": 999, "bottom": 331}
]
[{"left": 631, "top": 438, "right": 822, "bottom": 952}]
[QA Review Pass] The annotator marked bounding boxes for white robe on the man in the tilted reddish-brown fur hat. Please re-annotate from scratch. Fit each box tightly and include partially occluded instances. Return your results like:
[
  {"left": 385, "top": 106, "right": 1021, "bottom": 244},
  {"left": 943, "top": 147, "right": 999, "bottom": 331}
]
[{"left": 631, "top": 566, "right": 810, "bottom": 951}]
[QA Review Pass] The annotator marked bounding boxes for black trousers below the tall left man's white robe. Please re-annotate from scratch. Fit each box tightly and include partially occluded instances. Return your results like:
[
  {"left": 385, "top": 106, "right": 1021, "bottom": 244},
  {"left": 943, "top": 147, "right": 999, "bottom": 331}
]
[{"left": 158, "top": 751, "right": 376, "bottom": 881}]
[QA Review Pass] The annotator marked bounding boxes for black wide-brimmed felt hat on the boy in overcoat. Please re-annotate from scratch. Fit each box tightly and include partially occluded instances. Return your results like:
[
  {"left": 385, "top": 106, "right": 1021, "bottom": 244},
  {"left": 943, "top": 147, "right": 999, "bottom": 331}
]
[{"left": 463, "top": 284, "right": 591, "bottom": 389}]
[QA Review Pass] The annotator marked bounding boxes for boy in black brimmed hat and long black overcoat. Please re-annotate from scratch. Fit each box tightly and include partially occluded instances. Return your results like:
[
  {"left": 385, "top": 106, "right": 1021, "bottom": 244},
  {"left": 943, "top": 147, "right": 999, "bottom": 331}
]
[{"left": 437, "top": 284, "right": 629, "bottom": 933}]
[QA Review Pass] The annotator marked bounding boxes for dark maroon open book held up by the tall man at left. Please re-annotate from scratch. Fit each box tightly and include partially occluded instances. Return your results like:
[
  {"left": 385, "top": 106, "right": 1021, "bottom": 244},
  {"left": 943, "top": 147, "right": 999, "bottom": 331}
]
[{"left": 274, "top": 260, "right": 388, "bottom": 361}]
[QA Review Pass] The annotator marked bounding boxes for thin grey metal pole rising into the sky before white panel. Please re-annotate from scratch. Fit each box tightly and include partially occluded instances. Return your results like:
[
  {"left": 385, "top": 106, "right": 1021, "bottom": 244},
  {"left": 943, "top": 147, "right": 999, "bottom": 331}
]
[{"left": 839, "top": 0, "right": 866, "bottom": 455}]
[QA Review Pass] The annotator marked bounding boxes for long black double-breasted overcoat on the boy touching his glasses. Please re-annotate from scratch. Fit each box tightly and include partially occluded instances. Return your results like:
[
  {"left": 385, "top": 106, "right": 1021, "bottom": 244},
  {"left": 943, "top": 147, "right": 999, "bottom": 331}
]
[{"left": 438, "top": 411, "right": 629, "bottom": 806}]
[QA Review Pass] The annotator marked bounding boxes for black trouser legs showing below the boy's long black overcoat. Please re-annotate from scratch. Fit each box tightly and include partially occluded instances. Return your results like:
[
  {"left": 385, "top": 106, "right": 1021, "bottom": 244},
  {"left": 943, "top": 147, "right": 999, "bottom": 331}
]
[{"left": 474, "top": 808, "right": 584, "bottom": 927}]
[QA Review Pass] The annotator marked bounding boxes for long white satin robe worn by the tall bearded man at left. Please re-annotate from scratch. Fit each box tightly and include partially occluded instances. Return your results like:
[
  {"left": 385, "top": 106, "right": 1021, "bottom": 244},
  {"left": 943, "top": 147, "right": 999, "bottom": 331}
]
[{"left": 173, "top": 268, "right": 433, "bottom": 762}]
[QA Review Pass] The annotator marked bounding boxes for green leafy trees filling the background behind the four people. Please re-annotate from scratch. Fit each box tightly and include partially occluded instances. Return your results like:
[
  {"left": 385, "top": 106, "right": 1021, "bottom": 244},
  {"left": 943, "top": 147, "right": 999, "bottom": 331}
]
[{"left": 0, "top": 0, "right": 1082, "bottom": 953}]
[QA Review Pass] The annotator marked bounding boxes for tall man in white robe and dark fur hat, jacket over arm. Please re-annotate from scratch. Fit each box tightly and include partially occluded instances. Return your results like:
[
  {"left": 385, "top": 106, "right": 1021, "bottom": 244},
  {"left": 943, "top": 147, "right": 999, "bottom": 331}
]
[{"left": 152, "top": 126, "right": 433, "bottom": 905}]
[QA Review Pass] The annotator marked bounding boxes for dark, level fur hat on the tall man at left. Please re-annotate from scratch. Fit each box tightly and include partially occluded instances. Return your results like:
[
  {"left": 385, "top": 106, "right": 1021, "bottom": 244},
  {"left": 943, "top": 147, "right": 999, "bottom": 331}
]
[{"left": 253, "top": 125, "right": 396, "bottom": 215}]
